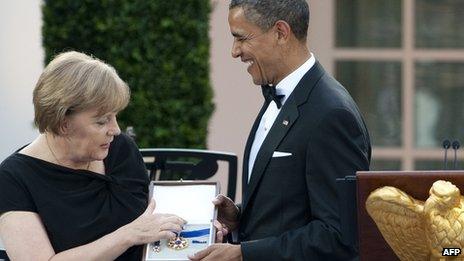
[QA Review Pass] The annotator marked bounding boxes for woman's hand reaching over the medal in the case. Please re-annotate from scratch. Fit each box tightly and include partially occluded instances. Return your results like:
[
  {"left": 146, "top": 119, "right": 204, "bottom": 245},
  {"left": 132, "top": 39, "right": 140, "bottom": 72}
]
[{"left": 119, "top": 200, "right": 186, "bottom": 246}]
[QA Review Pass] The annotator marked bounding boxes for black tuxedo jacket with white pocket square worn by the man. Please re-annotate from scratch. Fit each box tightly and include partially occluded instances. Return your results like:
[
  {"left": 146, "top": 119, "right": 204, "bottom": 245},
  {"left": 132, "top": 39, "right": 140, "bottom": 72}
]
[{"left": 239, "top": 62, "right": 371, "bottom": 261}]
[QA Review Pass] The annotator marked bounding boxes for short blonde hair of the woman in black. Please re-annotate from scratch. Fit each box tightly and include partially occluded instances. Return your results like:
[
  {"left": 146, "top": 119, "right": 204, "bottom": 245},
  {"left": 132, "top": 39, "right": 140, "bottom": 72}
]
[{"left": 32, "top": 51, "right": 130, "bottom": 135}]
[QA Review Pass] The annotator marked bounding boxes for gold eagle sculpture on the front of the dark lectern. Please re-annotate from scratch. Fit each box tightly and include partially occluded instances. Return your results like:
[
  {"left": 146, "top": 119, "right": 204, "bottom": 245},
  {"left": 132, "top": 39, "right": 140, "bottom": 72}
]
[{"left": 366, "top": 180, "right": 464, "bottom": 260}]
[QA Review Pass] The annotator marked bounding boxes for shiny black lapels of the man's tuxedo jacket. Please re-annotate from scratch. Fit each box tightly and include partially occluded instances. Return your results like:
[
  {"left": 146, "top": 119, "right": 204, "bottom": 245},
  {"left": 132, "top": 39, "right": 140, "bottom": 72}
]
[{"left": 242, "top": 62, "right": 324, "bottom": 212}]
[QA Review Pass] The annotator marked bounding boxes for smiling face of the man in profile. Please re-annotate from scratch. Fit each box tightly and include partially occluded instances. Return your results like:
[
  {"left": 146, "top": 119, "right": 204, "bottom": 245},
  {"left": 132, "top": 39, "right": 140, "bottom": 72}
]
[{"left": 229, "top": 7, "right": 280, "bottom": 85}]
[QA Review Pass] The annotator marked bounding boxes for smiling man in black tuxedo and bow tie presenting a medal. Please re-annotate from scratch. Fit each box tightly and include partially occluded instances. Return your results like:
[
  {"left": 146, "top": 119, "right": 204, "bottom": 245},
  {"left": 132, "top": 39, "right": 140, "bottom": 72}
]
[{"left": 191, "top": 0, "right": 371, "bottom": 260}]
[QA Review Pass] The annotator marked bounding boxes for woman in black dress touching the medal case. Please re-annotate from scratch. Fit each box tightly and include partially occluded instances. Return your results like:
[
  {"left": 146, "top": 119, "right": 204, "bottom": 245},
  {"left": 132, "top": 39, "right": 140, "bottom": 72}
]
[{"left": 0, "top": 52, "right": 185, "bottom": 260}]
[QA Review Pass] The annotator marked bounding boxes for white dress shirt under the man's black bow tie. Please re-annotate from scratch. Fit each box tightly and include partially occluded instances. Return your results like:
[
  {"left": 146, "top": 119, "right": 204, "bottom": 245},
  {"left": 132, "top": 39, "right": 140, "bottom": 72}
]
[{"left": 248, "top": 53, "right": 316, "bottom": 182}]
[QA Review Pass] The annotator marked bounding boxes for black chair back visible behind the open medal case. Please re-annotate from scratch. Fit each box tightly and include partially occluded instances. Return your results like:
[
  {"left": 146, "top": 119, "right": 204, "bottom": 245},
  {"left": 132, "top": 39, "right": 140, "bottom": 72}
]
[{"left": 140, "top": 148, "right": 237, "bottom": 200}]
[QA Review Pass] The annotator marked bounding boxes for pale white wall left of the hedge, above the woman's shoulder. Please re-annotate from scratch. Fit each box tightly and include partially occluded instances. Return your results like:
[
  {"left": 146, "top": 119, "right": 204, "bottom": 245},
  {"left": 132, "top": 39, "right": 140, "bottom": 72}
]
[{"left": 0, "top": 0, "right": 43, "bottom": 161}]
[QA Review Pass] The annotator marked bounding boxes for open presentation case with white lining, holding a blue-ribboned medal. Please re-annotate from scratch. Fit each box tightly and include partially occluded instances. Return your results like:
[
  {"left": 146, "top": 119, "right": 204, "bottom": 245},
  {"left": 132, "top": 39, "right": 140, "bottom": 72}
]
[{"left": 144, "top": 181, "right": 219, "bottom": 261}]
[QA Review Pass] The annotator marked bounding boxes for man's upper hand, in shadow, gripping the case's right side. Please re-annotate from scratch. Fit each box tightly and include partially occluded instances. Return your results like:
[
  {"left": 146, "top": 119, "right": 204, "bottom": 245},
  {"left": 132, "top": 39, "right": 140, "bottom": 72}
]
[{"left": 213, "top": 195, "right": 239, "bottom": 231}]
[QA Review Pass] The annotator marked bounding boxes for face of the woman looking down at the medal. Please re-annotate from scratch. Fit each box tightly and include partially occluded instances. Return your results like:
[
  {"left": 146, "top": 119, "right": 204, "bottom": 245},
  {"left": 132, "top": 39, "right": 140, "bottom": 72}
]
[{"left": 64, "top": 109, "right": 121, "bottom": 162}]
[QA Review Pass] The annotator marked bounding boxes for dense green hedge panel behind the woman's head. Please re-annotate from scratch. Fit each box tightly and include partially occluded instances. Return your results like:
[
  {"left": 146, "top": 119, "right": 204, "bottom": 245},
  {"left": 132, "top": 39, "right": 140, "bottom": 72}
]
[{"left": 42, "top": 0, "right": 214, "bottom": 148}]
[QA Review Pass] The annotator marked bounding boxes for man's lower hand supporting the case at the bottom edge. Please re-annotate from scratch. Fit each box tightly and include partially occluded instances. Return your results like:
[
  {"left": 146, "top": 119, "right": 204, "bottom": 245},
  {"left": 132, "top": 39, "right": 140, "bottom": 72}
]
[{"left": 189, "top": 244, "right": 242, "bottom": 261}]
